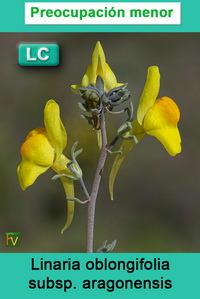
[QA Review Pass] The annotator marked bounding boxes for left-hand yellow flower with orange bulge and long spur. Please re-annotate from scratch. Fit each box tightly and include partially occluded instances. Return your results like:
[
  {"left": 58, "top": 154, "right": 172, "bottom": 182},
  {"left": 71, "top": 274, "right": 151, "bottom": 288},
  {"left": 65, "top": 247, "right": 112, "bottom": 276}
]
[{"left": 17, "top": 100, "right": 74, "bottom": 232}]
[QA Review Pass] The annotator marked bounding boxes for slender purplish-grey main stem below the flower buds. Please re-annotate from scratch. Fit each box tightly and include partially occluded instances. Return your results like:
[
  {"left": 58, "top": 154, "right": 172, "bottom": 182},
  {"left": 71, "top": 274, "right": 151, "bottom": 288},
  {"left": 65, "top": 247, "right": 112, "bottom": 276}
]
[{"left": 87, "top": 110, "right": 108, "bottom": 253}]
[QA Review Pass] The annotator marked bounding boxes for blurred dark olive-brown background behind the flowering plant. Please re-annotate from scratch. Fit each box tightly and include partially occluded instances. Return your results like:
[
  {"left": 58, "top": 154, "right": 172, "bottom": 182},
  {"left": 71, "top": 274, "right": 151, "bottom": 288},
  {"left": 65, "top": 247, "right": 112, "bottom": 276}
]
[{"left": 0, "top": 33, "right": 200, "bottom": 252}]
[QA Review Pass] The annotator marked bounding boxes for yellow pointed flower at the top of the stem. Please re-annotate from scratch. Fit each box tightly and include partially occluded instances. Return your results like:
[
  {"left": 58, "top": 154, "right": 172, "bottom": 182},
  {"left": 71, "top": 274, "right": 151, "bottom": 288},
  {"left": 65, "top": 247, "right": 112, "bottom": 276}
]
[{"left": 71, "top": 42, "right": 122, "bottom": 93}]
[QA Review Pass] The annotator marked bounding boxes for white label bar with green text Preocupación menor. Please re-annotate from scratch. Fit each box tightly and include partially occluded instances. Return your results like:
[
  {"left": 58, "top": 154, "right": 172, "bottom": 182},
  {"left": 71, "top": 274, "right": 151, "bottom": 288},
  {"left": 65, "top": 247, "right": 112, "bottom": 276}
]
[{"left": 25, "top": 2, "right": 181, "bottom": 25}]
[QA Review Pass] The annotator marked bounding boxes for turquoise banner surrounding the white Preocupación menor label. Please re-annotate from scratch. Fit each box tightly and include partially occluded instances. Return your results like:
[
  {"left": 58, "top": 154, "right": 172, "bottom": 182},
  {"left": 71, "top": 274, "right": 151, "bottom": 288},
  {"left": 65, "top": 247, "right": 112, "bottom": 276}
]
[{"left": 0, "top": 0, "right": 200, "bottom": 32}]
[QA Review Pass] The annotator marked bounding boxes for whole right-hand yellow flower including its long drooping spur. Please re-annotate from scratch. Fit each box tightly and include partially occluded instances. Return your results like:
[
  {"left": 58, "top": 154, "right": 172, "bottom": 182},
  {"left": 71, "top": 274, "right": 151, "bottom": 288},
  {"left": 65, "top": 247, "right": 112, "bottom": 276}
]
[{"left": 109, "top": 66, "right": 181, "bottom": 199}]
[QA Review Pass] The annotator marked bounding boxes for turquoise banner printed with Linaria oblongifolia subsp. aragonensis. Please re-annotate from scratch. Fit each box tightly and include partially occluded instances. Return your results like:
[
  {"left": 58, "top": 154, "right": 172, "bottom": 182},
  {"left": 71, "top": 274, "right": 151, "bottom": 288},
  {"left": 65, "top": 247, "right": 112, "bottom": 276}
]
[{"left": 0, "top": 253, "right": 200, "bottom": 299}]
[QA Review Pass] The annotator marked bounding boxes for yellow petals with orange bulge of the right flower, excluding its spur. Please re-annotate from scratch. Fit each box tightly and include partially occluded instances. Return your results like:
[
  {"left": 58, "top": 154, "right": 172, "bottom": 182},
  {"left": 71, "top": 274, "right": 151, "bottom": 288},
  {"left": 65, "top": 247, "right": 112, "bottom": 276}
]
[{"left": 136, "top": 66, "right": 181, "bottom": 156}]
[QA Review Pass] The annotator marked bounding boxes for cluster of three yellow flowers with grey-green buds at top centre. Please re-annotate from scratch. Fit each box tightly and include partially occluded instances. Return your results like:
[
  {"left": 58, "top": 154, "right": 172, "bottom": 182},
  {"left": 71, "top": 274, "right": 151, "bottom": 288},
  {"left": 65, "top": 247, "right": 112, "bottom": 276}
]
[{"left": 17, "top": 42, "right": 181, "bottom": 232}]
